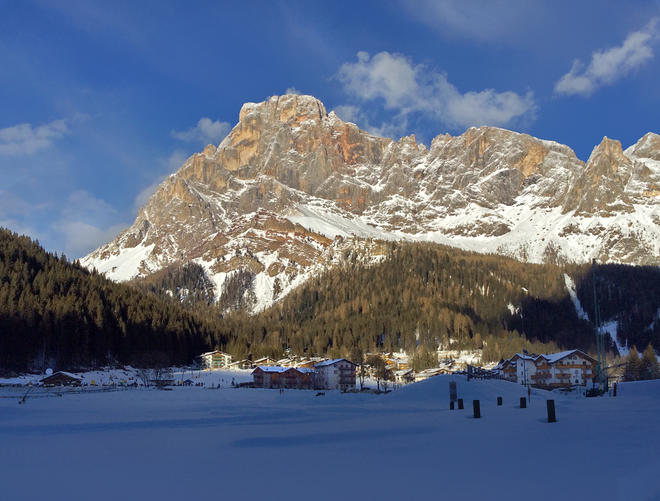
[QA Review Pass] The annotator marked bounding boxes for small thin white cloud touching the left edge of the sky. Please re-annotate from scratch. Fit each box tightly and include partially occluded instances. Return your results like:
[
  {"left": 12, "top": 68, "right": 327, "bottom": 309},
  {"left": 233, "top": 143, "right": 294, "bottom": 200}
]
[{"left": 0, "top": 119, "right": 69, "bottom": 156}]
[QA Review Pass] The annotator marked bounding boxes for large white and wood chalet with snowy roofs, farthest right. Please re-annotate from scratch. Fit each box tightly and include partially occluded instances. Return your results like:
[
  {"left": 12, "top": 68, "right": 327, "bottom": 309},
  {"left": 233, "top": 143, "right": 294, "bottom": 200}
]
[{"left": 495, "top": 350, "right": 596, "bottom": 388}]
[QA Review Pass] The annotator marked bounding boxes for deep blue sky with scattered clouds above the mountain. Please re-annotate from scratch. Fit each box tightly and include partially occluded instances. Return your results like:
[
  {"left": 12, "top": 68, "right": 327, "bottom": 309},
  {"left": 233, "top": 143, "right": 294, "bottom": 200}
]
[{"left": 0, "top": 0, "right": 660, "bottom": 258}]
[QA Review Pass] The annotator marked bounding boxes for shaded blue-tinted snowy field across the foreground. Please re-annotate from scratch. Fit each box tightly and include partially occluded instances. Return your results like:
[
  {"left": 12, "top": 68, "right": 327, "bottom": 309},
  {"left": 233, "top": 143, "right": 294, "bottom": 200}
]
[{"left": 0, "top": 376, "right": 660, "bottom": 501}]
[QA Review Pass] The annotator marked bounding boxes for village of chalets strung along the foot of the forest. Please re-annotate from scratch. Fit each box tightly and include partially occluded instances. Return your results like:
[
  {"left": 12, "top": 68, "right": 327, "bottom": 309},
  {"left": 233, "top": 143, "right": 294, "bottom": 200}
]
[{"left": 23, "top": 349, "right": 597, "bottom": 392}]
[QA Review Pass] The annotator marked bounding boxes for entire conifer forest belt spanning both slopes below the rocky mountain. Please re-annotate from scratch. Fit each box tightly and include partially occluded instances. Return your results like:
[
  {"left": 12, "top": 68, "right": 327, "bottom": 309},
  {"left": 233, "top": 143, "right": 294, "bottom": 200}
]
[{"left": 0, "top": 230, "right": 660, "bottom": 371}]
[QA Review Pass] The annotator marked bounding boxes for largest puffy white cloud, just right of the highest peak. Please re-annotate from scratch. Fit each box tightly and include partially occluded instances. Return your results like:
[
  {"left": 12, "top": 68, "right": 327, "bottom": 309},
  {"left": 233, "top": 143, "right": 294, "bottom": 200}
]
[{"left": 337, "top": 52, "right": 536, "bottom": 127}]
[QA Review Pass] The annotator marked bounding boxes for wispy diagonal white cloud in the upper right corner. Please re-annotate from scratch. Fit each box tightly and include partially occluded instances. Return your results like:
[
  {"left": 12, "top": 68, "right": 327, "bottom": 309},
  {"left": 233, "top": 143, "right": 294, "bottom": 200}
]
[{"left": 555, "top": 18, "right": 658, "bottom": 97}]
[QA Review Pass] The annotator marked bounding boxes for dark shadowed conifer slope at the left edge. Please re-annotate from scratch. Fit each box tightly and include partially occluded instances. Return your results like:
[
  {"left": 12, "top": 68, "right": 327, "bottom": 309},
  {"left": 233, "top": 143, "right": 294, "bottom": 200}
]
[{"left": 0, "top": 228, "right": 222, "bottom": 372}]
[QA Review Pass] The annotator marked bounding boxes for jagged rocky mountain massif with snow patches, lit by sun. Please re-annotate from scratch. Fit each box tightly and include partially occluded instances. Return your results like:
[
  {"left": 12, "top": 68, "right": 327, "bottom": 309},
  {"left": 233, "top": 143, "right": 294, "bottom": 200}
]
[{"left": 83, "top": 95, "right": 660, "bottom": 310}]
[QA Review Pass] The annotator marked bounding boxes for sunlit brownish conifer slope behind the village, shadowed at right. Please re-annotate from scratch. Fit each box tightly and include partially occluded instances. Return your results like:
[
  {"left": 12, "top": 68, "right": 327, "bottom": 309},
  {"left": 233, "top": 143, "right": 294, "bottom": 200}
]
[{"left": 214, "top": 243, "right": 660, "bottom": 367}]
